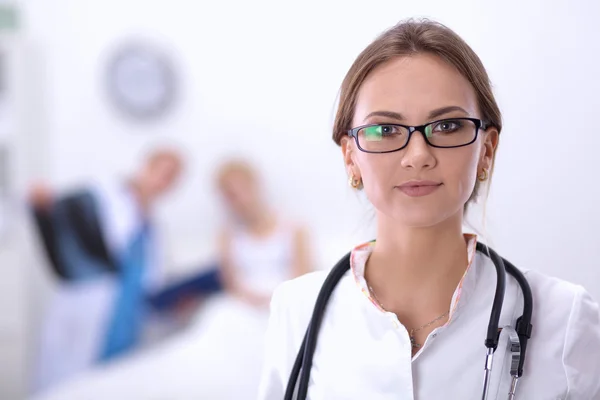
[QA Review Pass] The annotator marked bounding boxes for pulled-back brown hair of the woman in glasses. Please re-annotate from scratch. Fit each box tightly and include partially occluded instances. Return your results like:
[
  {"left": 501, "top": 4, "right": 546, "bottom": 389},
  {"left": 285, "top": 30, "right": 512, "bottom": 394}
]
[{"left": 333, "top": 19, "right": 502, "bottom": 199}]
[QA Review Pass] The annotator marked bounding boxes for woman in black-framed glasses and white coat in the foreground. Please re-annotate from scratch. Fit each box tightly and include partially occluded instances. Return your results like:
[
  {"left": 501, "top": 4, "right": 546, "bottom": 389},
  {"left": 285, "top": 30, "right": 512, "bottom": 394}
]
[{"left": 259, "top": 21, "right": 600, "bottom": 400}]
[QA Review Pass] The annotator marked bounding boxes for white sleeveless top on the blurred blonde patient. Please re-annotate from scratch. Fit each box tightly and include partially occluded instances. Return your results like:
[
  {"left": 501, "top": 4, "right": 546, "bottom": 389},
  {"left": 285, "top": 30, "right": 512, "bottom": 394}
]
[{"left": 229, "top": 223, "right": 294, "bottom": 296}]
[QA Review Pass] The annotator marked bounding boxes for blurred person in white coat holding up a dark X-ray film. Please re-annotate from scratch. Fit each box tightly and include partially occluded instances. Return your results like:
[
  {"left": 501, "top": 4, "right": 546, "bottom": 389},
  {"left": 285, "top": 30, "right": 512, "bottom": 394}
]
[{"left": 30, "top": 148, "right": 183, "bottom": 389}]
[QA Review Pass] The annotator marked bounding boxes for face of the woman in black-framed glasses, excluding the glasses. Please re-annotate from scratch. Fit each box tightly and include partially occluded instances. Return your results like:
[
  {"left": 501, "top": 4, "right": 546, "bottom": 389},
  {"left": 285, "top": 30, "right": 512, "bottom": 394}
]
[{"left": 342, "top": 54, "right": 498, "bottom": 227}]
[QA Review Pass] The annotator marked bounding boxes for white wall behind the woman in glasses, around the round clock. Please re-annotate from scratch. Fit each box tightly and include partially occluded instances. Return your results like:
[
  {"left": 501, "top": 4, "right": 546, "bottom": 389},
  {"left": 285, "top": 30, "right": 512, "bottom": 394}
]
[{"left": 9, "top": 0, "right": 600, "bottom": 396}]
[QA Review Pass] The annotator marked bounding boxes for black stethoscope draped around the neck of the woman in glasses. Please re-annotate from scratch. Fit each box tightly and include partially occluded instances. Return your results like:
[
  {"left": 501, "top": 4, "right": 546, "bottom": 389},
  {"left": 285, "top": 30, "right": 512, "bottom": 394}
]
[{"left": 284, "top": 243, "right": 533, "bottom": 400}]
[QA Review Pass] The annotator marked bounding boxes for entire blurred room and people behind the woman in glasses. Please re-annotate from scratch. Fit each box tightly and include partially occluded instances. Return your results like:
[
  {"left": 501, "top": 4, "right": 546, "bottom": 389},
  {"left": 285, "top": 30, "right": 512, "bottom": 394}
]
[{"left": 0, "top": 0, "right": 600, "bottom": 400}]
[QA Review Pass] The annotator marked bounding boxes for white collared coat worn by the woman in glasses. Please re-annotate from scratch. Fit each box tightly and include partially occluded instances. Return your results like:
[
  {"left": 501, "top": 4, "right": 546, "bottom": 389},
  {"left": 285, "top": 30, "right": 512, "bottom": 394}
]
[{"left": 259, "top": 237, "right": 600, "bottom": 400}]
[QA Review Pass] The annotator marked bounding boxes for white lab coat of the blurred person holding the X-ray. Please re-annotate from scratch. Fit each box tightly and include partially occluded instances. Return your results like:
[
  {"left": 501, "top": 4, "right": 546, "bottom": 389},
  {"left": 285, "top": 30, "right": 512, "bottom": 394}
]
[{"left": 33, "top": 182, "right": 162, "bottom": 391}]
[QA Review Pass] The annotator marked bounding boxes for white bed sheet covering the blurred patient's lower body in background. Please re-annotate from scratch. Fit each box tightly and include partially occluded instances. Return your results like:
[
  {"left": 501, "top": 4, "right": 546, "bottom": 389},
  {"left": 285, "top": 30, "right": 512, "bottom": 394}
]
[{"left": 34, "top": 295, "right": 268, "bottom": 400}]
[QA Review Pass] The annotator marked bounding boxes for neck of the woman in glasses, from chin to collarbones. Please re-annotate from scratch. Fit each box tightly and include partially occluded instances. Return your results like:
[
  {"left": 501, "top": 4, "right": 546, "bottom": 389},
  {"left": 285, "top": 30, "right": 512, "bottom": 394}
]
[{"left": 365, "top": 215, "right": 468, "bottom": 300}]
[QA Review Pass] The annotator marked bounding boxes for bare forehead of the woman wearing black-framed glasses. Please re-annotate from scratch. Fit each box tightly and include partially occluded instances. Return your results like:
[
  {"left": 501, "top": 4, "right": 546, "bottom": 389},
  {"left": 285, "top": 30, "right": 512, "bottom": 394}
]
[{"left": 354, "top": 54, "right": 478, "bottom": 126}]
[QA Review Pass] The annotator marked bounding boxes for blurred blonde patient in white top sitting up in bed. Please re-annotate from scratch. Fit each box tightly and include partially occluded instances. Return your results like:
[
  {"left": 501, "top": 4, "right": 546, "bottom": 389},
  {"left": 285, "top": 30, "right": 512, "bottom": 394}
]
[{"left": 217, "top": 160, "right": 310, "bottom": 307}]
